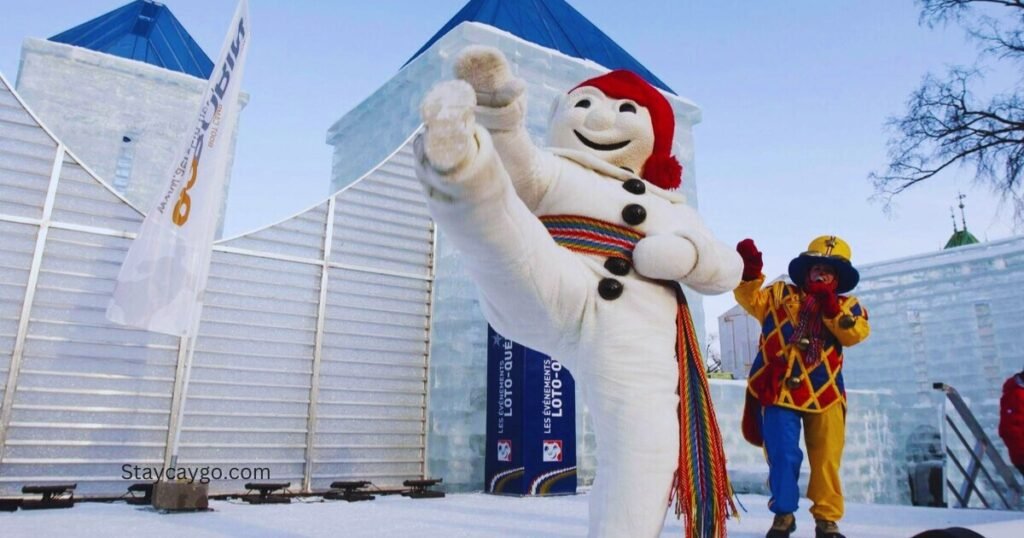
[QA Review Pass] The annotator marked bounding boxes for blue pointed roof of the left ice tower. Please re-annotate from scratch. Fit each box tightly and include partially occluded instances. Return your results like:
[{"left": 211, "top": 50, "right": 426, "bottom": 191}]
[{"left": 50, "top": 0, "right": 213, "bottom": 79}]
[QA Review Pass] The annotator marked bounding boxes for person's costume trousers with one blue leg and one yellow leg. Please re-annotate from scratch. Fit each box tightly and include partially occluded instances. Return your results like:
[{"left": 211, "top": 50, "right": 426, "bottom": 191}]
[{"left": 762, "top": 404, "right": 846, "bottom": 522}]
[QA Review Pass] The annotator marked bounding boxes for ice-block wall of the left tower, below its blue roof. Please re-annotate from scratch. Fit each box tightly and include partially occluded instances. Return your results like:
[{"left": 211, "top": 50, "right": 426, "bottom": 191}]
[{"left": 17, "top": 38, "right": 244, "bottom": 237}]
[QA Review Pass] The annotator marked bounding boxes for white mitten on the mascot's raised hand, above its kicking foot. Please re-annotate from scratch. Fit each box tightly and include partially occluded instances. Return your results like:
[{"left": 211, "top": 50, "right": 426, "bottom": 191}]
[{"left": 455, "top": 45, "right": 526, "bottom": 108}]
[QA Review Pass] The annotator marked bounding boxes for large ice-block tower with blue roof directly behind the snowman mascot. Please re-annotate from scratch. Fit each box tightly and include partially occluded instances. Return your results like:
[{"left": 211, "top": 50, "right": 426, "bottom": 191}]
[{"left": 327, "top": 0, "right": 703, "bottom": 489}]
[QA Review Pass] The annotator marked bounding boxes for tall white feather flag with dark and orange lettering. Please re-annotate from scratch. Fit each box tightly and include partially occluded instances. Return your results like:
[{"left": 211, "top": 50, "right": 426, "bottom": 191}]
[{"left": 106, "top": 0, "right": 252, "bottom": 336}]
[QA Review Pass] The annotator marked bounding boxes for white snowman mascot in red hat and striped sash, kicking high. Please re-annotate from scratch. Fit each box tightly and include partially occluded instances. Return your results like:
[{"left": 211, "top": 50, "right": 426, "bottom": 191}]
[{"left": 415, "top": 46, "right": 742, "bottom": 538}]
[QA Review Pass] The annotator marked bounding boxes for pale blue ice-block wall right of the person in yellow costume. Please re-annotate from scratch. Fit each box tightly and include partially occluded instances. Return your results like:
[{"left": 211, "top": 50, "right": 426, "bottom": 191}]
[{"left": 844, "top": 237, "right": 1024, "bottom": 501}]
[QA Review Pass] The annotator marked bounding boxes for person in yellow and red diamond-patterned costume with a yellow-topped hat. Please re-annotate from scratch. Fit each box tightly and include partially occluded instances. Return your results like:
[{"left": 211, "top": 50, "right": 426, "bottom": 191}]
[{"left": 733, "top": 236, "right": 870, "bottom": 538}]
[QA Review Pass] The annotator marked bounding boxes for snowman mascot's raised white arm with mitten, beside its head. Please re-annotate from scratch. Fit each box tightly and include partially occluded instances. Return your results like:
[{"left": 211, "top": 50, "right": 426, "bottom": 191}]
[{"left": 455, "top": 45, "right": 557, "bottom": 210}]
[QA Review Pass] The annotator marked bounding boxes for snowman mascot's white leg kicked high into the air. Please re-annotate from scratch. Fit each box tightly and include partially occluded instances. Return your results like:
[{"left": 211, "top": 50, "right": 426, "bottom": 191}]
[{"left": 415, "top": 92, "right": 596, "bottom": 358}]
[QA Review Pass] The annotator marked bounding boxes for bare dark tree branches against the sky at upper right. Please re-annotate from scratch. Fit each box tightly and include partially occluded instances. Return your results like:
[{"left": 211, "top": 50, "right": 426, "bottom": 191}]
[{"left": 869, "top": 0, "right": 1024, "bottom": 222}]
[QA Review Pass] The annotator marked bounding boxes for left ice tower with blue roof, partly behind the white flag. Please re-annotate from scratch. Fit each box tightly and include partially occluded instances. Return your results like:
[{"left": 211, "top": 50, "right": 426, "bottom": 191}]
[{"left": 16, "top": 0, "right": 248, "bottom": 236}]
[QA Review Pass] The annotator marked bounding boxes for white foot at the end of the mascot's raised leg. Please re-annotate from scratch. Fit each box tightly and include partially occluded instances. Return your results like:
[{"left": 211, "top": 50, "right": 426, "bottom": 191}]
[{"left": 420, "top": 80, "right": 476, "bottom": 174}]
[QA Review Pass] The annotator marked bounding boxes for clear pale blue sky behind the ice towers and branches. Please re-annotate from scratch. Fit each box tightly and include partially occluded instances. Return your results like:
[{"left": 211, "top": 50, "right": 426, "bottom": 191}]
[{"left": 0, "top": 0, "right": 1017, "bottom": 331}]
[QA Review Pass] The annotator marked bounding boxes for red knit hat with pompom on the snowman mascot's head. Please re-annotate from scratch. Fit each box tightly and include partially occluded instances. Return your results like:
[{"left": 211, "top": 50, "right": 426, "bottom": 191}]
[{"left": 569, "top": 69, "right": 683, "bottom": 189}]
